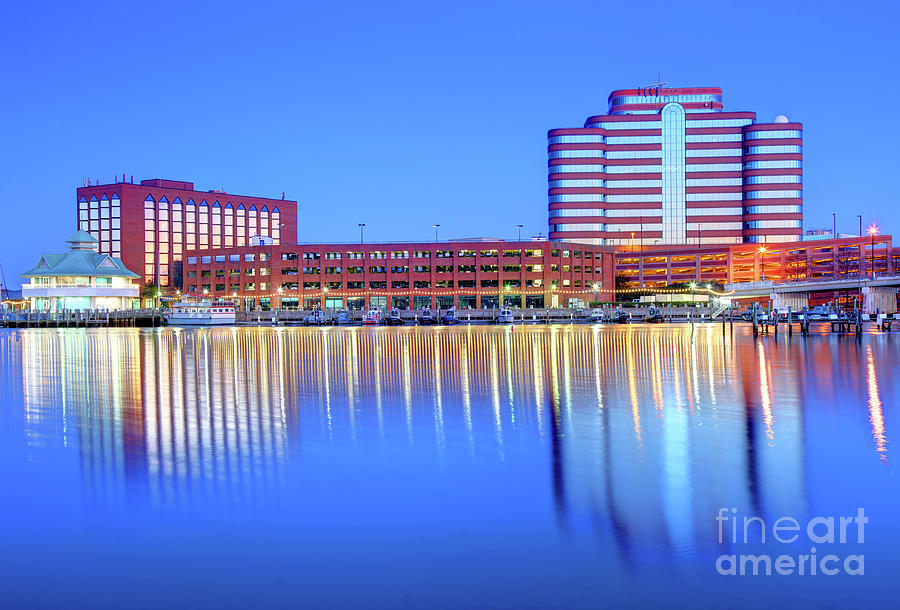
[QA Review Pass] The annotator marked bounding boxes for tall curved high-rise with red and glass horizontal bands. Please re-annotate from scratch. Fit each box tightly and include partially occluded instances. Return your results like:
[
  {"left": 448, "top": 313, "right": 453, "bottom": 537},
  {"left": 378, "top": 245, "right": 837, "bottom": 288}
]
[{"left": 548, "top": 87, "right": 803, "bottom": 247}]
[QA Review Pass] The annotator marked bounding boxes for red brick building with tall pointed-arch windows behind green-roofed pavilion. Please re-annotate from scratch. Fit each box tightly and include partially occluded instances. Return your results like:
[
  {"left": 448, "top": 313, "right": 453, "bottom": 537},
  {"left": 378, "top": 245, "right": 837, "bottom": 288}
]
[{"left": 76, "top": 177, "right": 297, "bottom": 287}]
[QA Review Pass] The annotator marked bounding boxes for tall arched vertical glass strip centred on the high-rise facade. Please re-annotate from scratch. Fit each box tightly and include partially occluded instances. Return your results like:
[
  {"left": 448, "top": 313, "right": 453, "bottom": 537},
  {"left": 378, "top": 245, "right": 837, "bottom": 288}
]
[{"left": 660, "top": 103, "right": 685, "bottom": 244}]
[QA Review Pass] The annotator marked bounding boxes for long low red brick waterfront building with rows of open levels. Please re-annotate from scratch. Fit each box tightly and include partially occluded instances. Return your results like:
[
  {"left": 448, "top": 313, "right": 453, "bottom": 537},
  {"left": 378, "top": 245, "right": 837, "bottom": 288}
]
[{"left": 184, "top": 240, "right": 615, "bottom": 309}]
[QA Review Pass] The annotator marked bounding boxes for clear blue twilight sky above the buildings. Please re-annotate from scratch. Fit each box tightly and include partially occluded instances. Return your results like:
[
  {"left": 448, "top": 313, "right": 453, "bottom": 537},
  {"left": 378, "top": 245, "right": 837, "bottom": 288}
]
[{"left": 0, "top": 0, "right": 900, "bottom": 283}]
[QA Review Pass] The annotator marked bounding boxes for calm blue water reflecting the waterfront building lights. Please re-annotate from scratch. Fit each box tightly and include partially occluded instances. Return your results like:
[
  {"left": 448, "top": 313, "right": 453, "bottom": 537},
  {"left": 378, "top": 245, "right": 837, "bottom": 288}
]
[{"left": 0, "top": 325, "right": 900, "bottom": 608}]
